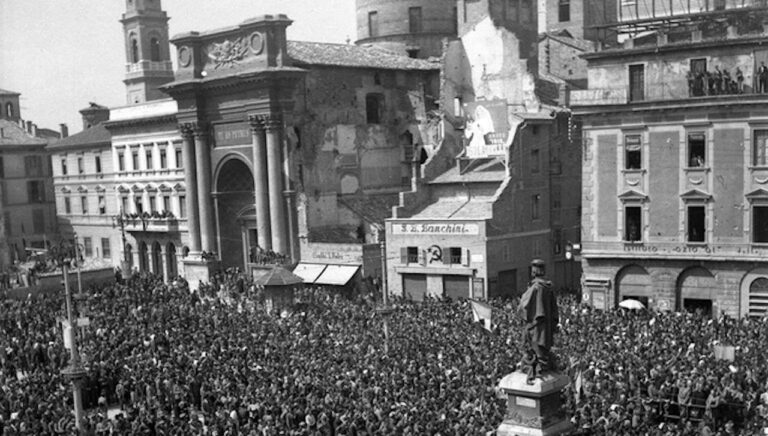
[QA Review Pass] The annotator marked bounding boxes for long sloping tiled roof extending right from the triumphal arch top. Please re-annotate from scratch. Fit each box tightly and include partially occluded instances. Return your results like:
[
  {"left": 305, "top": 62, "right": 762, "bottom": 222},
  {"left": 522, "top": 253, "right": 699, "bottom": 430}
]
[{"left": 288, "top": 41, "right": 440, "bottom": 71}]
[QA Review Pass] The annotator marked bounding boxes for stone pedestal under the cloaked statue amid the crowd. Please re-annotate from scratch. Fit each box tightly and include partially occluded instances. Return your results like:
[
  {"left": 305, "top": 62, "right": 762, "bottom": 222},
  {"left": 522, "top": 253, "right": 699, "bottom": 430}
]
[{"left": 496, "top": 371, "right": 572, "bottom": 436}]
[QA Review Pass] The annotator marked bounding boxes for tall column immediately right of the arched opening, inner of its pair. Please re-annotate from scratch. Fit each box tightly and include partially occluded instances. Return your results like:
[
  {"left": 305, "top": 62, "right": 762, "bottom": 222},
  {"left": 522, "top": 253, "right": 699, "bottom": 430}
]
[{"left": 248, "top": 115, "right": 272, "bottom": 250}]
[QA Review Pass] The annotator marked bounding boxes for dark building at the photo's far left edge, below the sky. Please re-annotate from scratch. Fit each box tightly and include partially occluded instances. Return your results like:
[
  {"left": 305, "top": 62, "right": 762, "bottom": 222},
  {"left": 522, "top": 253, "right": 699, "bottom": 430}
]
[{"left": 0, "top": 90, "right": 58, "bottom": 268}]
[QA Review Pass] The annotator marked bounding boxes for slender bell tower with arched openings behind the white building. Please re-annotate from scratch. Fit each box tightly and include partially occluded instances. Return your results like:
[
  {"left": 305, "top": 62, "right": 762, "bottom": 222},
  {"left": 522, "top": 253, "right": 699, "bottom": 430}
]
[{"left": 120, "top": 0, "right": 173, "bottom": 104}]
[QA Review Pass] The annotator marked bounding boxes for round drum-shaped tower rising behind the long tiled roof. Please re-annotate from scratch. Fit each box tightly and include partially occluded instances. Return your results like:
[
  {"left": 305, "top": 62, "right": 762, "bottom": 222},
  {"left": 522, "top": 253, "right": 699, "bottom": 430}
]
[{"left": 355, "top": 0, "right": 458, "bottom": 58}]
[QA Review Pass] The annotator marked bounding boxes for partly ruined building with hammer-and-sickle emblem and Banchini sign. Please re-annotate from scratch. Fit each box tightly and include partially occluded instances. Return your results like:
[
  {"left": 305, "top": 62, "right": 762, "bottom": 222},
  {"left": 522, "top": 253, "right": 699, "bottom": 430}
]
[{"left": 386, "top": 0, "right": 581, "bottom": 299}]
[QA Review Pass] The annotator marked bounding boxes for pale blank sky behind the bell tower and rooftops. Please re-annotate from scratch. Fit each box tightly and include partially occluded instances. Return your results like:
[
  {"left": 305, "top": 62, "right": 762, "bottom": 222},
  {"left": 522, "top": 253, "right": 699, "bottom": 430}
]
[{"left": 0, "top": 0, "right": 357, "bottom": 134}]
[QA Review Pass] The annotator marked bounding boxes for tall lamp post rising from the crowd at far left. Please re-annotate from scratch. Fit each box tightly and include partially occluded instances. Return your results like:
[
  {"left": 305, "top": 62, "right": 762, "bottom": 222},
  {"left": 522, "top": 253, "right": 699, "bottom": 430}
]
[{"left": 48, "top": 239, "right": 87, "bottom": 432}]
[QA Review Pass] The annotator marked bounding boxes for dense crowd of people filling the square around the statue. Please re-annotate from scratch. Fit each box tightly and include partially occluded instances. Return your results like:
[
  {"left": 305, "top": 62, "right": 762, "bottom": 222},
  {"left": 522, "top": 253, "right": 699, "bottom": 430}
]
[{"left": 0, "top": 271, "right": 768, "bottom": 436}]
